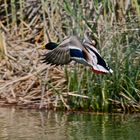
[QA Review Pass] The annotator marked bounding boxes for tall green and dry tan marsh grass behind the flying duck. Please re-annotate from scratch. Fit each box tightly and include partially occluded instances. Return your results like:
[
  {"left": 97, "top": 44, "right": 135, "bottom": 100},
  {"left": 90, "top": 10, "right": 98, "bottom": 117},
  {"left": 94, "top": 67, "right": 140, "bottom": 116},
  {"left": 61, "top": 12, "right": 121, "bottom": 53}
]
[{"left": 0, "top": 0, "right": 140, "bottom": 112}]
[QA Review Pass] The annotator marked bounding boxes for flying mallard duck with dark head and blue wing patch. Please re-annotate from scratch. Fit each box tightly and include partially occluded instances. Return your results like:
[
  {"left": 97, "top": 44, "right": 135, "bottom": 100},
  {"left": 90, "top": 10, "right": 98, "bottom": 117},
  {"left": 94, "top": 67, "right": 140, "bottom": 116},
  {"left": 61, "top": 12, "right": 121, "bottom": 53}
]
[{"left": 42, "top": 32, "right": 113, "bottom": 73}]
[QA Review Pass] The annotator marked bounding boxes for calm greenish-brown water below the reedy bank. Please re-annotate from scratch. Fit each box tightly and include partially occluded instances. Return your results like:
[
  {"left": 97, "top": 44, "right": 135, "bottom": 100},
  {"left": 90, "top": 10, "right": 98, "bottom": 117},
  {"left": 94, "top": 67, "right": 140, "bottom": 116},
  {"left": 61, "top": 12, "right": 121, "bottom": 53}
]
[{"left": 0, "top": 108, "right": 140, "bottom": 140}]
